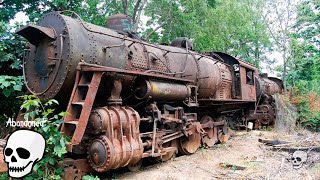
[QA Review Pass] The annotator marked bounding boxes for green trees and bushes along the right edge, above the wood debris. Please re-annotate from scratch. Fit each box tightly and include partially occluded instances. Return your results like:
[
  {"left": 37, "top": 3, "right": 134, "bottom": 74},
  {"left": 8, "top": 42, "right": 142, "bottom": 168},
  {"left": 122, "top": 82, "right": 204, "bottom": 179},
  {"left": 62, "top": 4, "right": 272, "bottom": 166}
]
[{"left": 287, "top": 0, "right": 320, "bottom": 131}]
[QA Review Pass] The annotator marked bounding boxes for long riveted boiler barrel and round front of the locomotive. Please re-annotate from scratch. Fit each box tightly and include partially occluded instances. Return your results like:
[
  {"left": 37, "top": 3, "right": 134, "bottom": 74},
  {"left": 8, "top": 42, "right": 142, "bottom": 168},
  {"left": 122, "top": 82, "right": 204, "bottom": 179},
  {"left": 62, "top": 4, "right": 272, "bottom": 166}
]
[{"left": 17, "top": 12, "right": 236, "bottom": 103}]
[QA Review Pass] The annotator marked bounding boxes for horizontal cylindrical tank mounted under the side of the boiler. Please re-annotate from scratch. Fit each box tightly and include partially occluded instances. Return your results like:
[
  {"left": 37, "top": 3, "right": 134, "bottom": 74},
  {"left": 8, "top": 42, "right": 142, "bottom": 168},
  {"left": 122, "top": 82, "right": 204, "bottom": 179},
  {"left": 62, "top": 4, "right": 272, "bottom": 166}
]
[{"left": 135, "top": 80, "right": 191, "bottom": 101}]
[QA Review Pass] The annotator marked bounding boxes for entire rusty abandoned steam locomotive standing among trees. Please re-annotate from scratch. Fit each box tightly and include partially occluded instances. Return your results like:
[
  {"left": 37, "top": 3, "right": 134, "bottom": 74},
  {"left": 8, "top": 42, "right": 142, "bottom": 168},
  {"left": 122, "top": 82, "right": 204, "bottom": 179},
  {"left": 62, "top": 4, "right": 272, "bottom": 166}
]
[{"left": 17, "top": 12, "right": 282, "bottom": 177}]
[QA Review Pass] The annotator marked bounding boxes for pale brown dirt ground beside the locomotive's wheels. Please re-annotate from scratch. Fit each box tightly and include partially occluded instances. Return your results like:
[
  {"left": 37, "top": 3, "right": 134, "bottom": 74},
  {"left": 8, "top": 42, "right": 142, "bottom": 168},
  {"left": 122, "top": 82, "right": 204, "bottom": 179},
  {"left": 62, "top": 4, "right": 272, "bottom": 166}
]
[{"left": 109, "top": 131, "right": 320, "bottom": 180}]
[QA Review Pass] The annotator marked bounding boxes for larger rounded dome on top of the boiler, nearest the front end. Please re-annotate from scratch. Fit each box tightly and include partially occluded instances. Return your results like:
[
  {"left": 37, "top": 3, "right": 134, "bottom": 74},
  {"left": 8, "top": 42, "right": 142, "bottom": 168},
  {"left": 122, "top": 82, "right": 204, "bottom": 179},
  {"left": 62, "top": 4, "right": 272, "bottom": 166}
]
[{"left": 106, "top": 14, "right": 133, "bottom": 32}]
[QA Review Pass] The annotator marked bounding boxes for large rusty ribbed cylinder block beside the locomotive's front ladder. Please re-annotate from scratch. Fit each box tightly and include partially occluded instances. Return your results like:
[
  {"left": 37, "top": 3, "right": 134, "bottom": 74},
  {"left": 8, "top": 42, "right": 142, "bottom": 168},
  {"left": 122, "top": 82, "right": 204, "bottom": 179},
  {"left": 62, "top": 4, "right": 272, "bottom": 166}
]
[{"left": 87, "top": 106, "right": 143, "bottom": 172}]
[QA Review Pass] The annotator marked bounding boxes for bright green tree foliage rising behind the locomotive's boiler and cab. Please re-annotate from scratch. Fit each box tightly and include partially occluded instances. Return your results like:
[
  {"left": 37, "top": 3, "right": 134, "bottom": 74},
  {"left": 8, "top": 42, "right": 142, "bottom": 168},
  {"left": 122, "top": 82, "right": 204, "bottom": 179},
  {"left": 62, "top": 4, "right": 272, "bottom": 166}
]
[{"left": 143, "top": 0, "right": 271, "bottom": 66}]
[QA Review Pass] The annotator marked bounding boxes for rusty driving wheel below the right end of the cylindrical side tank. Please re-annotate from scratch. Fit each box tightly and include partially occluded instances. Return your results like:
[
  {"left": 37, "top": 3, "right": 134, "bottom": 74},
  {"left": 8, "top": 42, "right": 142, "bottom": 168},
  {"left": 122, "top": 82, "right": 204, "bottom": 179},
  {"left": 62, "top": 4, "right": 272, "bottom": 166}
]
[{"left": 178, "top": 124, "right": 201, "bottom": 155}]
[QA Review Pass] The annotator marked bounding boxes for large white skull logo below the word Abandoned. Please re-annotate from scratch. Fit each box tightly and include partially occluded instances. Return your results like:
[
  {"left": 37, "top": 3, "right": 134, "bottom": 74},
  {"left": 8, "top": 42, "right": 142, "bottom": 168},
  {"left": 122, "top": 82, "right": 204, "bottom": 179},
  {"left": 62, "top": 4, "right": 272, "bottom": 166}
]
[{"left": 3, "top": 130, "right": 45, "bottom": 178}]
